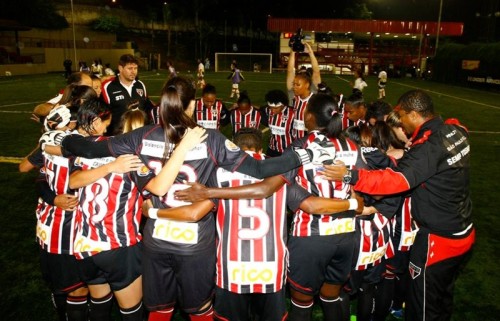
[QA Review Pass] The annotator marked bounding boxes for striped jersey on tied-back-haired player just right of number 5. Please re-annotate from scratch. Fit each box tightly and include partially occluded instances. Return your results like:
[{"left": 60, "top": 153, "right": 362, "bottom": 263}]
[{"left": 291, "top": 131, "right": 366, "bottom": 237}]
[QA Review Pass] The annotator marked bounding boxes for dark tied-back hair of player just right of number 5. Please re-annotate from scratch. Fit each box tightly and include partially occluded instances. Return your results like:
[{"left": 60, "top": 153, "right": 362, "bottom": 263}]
[{"left": 307, "top": 94, "right": 344, "bottom": 139}]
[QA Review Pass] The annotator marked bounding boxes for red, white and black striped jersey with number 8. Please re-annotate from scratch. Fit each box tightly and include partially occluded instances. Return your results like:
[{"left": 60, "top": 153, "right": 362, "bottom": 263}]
[{"left": 71, "top": 137, "right": 142, "bottom": 259}]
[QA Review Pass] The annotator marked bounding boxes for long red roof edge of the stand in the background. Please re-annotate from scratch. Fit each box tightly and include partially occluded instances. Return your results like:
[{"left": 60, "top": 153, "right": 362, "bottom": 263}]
[{"left": 267, "top": 17, "right": 464, "bottom": 36}]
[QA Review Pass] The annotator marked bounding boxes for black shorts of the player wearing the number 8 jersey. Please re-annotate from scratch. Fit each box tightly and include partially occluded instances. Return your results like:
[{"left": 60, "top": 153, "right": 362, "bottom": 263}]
[{"left": 78, "top": 243, "right": 142, "bottom": 291}]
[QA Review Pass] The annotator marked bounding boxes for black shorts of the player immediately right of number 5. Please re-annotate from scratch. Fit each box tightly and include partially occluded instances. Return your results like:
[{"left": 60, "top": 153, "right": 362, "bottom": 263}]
[{"left": 288, "top": 232, "right": 356, "bottom": 295}]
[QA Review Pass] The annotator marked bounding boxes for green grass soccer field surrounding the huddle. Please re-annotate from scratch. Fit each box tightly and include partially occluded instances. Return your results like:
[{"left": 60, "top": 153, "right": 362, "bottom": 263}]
[{"left": 0, "top": 70, "right": 500, "bottom": 321}]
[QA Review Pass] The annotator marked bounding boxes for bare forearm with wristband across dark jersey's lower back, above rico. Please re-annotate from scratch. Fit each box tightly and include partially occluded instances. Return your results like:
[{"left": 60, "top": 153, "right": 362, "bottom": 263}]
[{"left": 142, "top": 200, "right": 214, "bottom": 222}]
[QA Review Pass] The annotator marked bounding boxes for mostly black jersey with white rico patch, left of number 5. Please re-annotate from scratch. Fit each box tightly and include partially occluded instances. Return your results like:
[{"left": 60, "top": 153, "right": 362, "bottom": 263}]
[{"left": 108, "top": 125, "right": 248, "bottom": 254}]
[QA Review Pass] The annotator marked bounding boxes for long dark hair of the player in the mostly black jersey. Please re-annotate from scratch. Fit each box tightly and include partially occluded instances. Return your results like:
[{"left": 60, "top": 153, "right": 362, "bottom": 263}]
[{"left": 160, "top": 77, "right": 197, "bottom": 161}]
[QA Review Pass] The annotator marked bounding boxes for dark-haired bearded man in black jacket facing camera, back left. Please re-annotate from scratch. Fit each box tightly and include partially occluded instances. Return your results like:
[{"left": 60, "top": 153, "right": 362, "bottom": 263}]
[{"left": 102, "top": 54, "right": 154, "bottom": 136}]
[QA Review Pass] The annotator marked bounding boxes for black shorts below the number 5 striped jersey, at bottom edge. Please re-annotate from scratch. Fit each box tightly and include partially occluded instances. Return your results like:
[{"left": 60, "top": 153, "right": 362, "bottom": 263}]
[{"left": 214, "top": 287, "right": 287, "bottom": 321}]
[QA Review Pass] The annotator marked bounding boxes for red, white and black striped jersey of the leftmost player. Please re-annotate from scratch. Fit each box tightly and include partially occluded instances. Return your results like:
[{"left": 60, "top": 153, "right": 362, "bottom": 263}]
[{"left": 36, "top": 149, "right": 75, "bottom": 254}]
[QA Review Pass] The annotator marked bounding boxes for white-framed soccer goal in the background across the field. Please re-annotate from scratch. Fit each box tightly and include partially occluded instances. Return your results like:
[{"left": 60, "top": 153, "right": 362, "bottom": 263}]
[{"left": 215, "top": 52, "right": 273, "bottom": 73}]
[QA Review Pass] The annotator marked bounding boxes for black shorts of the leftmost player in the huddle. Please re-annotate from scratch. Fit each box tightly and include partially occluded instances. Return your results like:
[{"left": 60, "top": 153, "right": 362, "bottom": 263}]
[{"left": 40, "top": 249, "right": 85, "bottom": 294}]
